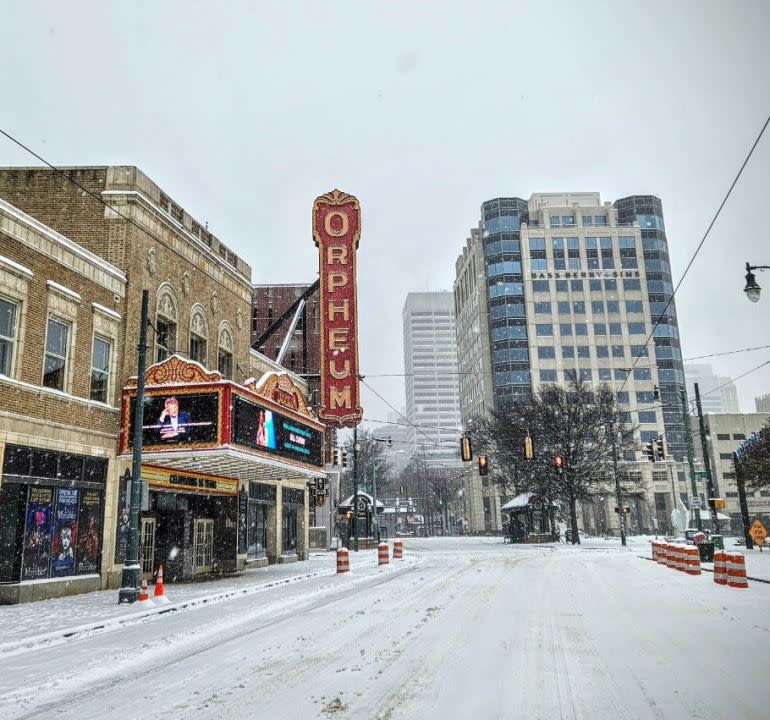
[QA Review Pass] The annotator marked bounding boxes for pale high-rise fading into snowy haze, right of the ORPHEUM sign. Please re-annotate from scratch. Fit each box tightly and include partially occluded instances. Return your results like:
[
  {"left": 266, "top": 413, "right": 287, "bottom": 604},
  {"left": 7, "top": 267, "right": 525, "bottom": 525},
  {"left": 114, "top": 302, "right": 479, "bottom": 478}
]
[{"left": 403, "top": 292, "right": 460, "bottom": 463}]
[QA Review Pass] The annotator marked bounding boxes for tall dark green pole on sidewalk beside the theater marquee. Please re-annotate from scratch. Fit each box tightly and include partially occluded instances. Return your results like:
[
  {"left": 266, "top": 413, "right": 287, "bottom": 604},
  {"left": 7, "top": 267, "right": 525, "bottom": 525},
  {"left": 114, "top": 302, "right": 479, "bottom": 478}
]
[{"left": 118, "top": 290, "right": 150, "bottom": 603}]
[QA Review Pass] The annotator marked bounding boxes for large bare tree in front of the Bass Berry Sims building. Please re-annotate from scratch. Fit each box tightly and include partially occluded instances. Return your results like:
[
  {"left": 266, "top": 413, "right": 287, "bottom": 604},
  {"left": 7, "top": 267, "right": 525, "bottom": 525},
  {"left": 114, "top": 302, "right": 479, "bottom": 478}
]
[{"left": 471, "top": 376, "right": 634, "bottom": 543}]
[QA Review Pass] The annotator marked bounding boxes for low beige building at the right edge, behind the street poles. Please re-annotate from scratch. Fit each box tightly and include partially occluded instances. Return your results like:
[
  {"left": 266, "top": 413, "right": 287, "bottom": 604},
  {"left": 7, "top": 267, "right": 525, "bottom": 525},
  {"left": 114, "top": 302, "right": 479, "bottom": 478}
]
[{"left": 690, "top": 413, "right": 770, "bottom": 534}]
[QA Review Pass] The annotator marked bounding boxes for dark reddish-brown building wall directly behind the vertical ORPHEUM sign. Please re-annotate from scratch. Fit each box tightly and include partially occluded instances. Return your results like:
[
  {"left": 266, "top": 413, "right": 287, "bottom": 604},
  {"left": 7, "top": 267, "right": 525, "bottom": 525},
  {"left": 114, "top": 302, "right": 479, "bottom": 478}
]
[{"left": 251, "top": 284, "right": 321, "bottom": 375}]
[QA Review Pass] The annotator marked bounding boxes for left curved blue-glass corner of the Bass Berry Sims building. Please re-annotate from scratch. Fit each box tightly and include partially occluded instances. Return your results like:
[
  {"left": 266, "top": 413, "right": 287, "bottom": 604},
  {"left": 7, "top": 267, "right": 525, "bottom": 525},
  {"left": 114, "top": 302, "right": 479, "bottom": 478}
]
[{"left": 481, "top": 198, "right": 532, "bottom": 407}]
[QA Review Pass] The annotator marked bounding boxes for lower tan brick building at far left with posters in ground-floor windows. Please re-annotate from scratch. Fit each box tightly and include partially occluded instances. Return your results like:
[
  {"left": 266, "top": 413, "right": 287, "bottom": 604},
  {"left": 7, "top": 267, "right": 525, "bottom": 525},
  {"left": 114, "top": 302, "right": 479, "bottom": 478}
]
[{"left": 0, "top": 200, "right": 126, "bottom": 602}]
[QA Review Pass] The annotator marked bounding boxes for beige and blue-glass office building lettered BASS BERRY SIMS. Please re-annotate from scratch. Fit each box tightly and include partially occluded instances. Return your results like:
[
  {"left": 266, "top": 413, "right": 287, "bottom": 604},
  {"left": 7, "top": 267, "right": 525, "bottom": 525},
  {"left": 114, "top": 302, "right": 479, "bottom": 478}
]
[{"left": 454, "top": 193, "right": 685, "bottom": 460}]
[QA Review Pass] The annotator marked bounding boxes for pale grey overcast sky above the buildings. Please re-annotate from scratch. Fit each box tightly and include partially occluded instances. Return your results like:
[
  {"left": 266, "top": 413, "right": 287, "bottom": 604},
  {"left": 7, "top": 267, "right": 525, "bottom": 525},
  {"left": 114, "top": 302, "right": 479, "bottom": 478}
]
[{"left": 0, "top": 0, "right": 770, "bottom": 418}]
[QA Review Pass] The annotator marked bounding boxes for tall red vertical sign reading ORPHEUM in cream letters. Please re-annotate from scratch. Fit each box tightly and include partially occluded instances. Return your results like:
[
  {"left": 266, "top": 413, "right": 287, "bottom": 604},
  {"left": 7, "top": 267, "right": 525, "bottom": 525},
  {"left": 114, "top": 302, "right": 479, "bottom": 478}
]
[{"left": 313, "top": 190, "right": 363, "bottom": 427}]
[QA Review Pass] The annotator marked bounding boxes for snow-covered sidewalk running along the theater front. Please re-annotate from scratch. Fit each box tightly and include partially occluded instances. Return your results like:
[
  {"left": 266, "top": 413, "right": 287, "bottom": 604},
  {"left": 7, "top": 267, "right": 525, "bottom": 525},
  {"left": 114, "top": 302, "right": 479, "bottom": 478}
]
[{"left": 0, "top": 551, "right": 390, "bottom": 655}]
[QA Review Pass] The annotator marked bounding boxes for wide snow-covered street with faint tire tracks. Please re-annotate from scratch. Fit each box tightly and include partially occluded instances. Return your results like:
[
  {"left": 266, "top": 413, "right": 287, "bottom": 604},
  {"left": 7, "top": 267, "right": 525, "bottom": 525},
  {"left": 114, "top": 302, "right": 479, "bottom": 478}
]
[{"left": 0, "top": 538, "right": 770, "bottom": 720}]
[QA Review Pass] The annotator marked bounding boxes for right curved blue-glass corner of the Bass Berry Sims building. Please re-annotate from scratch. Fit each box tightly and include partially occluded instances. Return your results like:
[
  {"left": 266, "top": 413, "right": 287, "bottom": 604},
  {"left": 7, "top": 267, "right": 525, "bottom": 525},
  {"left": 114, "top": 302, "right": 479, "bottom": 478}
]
[{"left": 615, "top": 195, "right": 686, "bottom": 460}]
